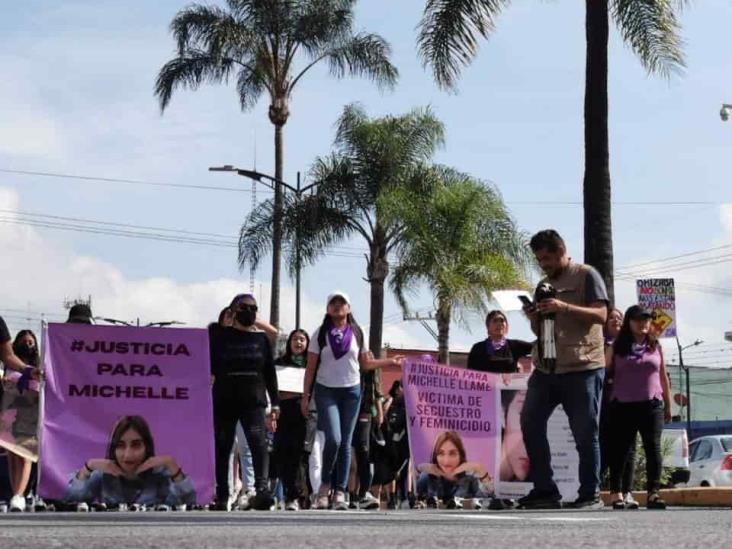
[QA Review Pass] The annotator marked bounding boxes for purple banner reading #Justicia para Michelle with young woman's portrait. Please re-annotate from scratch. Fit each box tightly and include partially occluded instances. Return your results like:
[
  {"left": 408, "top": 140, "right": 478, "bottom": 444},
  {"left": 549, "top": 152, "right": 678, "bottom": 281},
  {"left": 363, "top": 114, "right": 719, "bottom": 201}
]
[{"left": 40, "top": 324, "right": 214, "bottom": 505}]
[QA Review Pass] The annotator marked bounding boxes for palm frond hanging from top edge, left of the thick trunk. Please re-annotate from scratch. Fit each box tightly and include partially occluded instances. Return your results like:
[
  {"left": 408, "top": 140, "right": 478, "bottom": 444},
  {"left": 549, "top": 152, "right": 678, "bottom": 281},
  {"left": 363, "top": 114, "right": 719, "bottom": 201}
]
[{"left": 417, "top": 0, "right": 509, "bottom": 89}]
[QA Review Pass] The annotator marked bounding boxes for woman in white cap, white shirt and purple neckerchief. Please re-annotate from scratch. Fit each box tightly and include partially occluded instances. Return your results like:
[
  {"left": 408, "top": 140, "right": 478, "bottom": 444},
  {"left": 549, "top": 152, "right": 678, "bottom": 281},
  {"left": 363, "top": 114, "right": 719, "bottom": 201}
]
[{"left": 301, "top": 291, "right": 401, "bottom": 510}]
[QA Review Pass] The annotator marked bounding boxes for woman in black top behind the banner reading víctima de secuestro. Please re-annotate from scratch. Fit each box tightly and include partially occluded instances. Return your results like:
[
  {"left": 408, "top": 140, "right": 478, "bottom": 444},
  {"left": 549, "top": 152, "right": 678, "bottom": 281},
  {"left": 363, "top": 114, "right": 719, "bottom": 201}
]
[{"left": 468, "top": 310, "right": 532, "bottom": 374}]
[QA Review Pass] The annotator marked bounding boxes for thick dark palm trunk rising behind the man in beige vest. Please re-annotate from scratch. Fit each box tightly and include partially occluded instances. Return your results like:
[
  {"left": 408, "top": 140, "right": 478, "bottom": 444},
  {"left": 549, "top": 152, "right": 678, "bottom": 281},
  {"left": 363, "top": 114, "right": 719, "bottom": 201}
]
[{"left": 583, "top": 0, "right": 615, "bottom": 303}]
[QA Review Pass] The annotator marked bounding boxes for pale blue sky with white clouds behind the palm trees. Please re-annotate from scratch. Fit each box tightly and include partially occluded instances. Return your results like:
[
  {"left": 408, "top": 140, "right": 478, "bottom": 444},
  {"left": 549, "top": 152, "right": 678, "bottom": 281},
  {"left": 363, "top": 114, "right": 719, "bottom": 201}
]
[{"left": 0, "top": 0, "right": 732, "bottom": 365}]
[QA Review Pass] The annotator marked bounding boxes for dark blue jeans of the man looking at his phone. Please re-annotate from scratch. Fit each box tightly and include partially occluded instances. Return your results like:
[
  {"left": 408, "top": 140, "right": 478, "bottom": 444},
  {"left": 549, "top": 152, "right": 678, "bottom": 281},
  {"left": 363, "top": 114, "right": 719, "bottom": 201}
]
[{"left": 521, "top": 368, "right": 605, "bottom": 499}]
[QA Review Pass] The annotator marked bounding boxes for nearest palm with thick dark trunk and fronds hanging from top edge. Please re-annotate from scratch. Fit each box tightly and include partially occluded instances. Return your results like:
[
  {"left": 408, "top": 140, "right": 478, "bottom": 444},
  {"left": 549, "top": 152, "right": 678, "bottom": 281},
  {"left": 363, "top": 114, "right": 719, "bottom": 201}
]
[{"left": 418, "top": 0, "right": 687, "bottom": 300}]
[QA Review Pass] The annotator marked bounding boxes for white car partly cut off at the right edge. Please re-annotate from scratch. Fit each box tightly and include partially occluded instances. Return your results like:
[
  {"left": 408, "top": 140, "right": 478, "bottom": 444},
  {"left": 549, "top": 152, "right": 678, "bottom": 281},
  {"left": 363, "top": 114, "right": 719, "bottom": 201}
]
[{"left": 687, "top": 435, "right": 732, "bottom": 486}]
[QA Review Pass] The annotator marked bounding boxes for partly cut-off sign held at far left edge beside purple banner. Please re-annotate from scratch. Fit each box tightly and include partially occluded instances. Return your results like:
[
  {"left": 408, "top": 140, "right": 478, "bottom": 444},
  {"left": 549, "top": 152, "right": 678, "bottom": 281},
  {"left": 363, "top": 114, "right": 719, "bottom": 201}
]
[{"left": 0, "top": 369, "right": 39, "bottom": 462}]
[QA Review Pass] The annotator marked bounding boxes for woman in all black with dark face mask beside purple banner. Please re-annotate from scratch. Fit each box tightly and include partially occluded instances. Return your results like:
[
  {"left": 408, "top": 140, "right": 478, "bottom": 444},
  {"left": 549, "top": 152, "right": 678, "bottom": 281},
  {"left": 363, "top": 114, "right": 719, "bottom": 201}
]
[{"left": 210, "top": 294, "right": 279, "bottom": 511}]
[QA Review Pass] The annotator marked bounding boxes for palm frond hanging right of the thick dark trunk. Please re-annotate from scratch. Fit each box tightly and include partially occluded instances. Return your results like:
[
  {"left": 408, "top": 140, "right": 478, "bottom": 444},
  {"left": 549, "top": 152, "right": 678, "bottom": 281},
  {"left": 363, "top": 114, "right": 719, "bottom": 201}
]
[{"left": 611, "top": 0, "right": 686, "bottom": 77}]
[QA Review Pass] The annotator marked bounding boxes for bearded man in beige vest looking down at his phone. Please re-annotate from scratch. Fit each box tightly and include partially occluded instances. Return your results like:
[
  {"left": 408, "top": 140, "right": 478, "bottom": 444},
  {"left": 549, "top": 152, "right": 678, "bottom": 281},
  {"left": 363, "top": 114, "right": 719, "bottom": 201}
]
[{"left": 518, "top": 229, "right": 609, "bottom": 509}]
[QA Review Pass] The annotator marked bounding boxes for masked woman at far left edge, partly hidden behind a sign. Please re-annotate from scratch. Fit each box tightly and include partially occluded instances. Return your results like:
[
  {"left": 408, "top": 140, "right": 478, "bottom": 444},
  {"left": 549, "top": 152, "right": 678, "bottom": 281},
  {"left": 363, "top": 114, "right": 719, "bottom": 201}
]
[{"left": 2, "top": 330, "right": 40, "bottom": 512}]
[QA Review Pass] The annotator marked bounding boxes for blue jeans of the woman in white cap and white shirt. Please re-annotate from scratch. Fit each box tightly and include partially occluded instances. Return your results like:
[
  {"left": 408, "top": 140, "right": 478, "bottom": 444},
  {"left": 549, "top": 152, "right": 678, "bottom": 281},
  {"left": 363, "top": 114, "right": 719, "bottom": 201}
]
[{"left": 314, "top": 383, "right": 361, "bottom": 492}]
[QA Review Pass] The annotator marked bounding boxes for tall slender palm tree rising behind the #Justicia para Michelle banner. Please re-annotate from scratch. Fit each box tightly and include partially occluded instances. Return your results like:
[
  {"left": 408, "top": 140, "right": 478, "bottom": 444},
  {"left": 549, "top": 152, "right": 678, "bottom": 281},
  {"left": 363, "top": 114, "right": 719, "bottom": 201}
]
[{"left": 155, "top": 0, "right": 398, "bottom": 326}]
